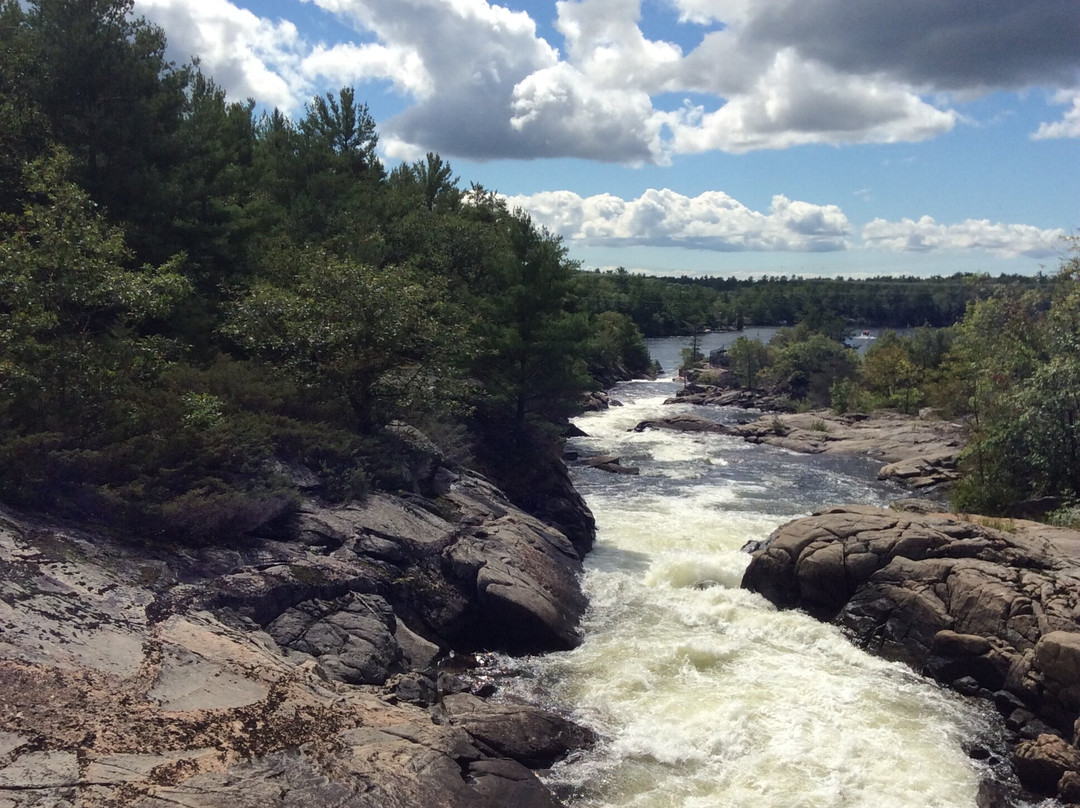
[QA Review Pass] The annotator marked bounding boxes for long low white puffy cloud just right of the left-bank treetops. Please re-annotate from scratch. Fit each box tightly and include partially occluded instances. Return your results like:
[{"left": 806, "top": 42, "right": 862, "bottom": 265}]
[{"left": 507, "top": 188, "right": 852, "bottom": 252}]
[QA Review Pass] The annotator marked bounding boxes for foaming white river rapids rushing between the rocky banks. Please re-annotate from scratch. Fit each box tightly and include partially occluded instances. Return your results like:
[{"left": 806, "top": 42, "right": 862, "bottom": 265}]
[{"left": 496, "top": 341, "right": 1010, "bottom": 808}]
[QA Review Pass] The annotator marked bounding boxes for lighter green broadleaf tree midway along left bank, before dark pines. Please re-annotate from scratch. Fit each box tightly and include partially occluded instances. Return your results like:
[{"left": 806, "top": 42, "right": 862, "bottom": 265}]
[{"left": 221, "top": 245, "right": 468, "bottom": 432}]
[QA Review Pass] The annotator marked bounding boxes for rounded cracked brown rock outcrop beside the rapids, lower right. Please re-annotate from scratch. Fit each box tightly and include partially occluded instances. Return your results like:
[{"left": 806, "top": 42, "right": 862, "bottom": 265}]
[{"left": 743, "top": 506, "right": 1080, "bottom": 804}]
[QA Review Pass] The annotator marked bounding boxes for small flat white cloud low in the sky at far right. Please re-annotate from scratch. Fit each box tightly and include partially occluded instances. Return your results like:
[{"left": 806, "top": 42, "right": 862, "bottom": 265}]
[{"left": 862, "top": 216, "right": 1066, "bottom": 258}]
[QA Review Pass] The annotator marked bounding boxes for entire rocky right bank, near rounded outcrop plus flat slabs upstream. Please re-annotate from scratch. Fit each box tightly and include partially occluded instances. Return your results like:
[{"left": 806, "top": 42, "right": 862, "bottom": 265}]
[{"left": 565, "top": 354, "right": 1080, "bottom": 806}]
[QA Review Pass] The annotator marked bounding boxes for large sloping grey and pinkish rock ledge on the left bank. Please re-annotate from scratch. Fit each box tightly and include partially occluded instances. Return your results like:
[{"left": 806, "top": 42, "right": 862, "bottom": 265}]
[{"left": 0, "top": 474, "right": 593, "bottom": 808}]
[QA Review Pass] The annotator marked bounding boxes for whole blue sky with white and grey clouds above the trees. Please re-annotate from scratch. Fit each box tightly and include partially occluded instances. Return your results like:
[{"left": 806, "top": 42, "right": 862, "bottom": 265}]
[{"left": 135, "top": 0, "right": 1080, "bottom": 277}]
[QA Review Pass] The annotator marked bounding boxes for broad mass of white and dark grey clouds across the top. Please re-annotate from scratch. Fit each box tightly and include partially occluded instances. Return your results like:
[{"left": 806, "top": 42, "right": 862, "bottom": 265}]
[{"left": 136, "top": 0, "right": 1080, "bottom": 163}]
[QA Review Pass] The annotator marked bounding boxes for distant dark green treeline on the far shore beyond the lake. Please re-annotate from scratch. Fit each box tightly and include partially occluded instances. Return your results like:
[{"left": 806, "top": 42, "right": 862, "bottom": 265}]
[{"left": 576, "top": 268, "right": 1051, "bottom": 337}]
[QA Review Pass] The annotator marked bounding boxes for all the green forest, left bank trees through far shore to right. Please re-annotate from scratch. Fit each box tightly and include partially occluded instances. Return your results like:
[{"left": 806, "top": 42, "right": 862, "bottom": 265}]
[{"left": 0, "top": 0, "right": 1080, "bottom": 542}]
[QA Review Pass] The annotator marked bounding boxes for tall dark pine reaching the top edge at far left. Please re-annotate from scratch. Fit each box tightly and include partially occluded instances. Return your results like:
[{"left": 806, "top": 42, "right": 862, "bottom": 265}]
[{"left": 24, "top": 0, "right": 188, "bottom": 253}]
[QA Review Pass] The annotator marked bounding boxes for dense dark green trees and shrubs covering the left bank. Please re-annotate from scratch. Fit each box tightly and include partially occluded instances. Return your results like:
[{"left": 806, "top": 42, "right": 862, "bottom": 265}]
[{"left": 0, "top": 0, "right": 630, "bottom": 542}]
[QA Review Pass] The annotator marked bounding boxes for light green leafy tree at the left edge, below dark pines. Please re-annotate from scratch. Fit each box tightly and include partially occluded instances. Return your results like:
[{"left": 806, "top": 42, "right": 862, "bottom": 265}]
[{"left": 0, "top": 153, "right": 189, "bottom": 433}]
